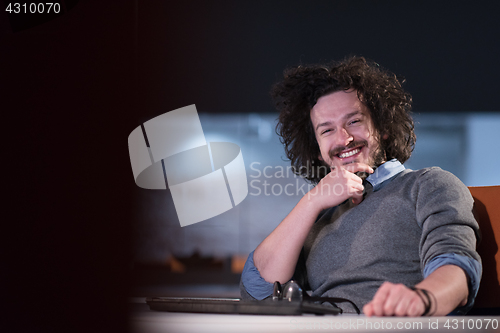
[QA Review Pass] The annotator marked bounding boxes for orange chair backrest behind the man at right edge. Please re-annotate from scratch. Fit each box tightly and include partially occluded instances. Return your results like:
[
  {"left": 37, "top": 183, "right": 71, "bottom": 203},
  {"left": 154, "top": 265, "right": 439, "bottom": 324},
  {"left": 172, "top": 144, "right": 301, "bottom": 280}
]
[{"left": 469, "top": 186, "right": 500, "bottom": 308}]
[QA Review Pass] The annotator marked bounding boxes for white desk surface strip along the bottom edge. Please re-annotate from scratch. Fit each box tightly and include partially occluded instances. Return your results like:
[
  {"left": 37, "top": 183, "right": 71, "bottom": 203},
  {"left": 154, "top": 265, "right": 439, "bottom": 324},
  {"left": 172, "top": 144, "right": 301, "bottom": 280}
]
[{"left": 130, "top": 301, "right": 500, "bottom": 333}]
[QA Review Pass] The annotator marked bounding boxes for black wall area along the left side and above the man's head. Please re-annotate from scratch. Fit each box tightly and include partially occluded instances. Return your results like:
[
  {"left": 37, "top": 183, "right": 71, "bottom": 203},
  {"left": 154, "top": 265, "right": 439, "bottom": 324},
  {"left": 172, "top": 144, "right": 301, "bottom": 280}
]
[{"left": 0, "top": 0, "right": 500, "bottom": 332}]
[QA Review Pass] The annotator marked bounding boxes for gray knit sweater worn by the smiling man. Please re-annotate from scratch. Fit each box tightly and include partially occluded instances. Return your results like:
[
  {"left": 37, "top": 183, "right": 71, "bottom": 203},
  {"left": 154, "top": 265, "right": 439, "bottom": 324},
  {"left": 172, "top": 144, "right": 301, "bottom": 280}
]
[{"left": 243, "top": 167, "right": 481, "bottom": 312}]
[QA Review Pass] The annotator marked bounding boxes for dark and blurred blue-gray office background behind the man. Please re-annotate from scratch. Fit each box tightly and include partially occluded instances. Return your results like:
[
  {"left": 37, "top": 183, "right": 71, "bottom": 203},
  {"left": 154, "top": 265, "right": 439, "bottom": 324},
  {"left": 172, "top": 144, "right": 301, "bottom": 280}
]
[{"left": 0, "top": 0, "right": 500, "bottom": 331}]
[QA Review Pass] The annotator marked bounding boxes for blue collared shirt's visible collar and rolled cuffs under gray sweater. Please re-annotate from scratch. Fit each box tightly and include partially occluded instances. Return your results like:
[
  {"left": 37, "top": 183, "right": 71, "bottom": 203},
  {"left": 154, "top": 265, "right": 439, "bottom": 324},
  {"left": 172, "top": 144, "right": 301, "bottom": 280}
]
[{"left": 241, "top": 159, "right": 482, "bottom": 313}]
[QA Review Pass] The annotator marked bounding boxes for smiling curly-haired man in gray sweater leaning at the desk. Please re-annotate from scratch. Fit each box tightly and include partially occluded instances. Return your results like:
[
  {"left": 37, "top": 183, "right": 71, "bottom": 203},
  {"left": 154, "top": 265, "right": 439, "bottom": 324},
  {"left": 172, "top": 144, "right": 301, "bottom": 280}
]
[{"left": 241, "top": 57, "right": 481, "bottom": 316}]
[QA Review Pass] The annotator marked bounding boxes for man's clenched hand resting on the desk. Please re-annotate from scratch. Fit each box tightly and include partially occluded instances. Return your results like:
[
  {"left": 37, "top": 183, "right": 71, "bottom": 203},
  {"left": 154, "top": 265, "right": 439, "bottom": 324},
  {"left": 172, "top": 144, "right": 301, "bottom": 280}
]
[{"left": 363, "top": 282, "right": 425, "bottom": 317}]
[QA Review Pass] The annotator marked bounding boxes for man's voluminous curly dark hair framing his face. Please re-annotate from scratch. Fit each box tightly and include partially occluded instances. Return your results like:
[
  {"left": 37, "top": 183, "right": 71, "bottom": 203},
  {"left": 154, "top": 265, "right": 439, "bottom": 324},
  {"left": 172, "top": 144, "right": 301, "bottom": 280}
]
[{"left": 271, "top": 56, "right": 416, "bottom": 183}]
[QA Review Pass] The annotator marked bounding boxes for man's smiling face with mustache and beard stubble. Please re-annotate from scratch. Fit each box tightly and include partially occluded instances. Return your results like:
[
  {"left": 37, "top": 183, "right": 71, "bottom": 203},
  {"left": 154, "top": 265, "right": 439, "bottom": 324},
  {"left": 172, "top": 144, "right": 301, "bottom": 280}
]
[{"left": 311, "top": 90, "right": 385, "bottom": 168}]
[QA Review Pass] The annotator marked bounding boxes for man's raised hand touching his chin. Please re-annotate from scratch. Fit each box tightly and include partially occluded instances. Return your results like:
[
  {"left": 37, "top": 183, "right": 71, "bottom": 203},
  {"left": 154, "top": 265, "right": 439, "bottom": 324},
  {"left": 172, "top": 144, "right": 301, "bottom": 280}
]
[{"left": 307, "top": 163, "right": 373, "bottom": 211}]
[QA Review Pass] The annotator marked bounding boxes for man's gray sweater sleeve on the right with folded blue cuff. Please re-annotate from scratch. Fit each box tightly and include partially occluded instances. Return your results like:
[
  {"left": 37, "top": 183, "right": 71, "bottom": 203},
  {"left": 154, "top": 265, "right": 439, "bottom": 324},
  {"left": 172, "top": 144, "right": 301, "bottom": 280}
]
[{"left": 414, "top": 168, "right": 482, "bottom": 310}]
